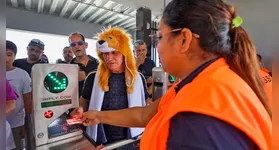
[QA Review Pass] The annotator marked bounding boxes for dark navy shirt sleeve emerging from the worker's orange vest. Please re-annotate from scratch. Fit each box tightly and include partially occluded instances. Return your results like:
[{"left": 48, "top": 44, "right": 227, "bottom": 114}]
[{"left": 167, "top": 112, "right": 259, "bottom": 150}]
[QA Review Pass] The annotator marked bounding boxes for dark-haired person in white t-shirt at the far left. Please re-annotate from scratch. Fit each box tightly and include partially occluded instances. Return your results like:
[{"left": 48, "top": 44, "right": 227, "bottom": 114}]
[{"left": 6, "top": 41, "right": 32, "bottom": 150}]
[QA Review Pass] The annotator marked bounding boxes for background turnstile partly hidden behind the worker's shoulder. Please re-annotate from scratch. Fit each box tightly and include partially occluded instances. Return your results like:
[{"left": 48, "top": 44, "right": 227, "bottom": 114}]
[{"left": 152, "top": 67, "right": 176, "bottom": 101}]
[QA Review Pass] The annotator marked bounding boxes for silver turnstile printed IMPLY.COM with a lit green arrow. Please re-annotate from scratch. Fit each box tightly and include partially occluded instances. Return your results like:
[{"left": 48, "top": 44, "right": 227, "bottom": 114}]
[{"left": 25, "top": 64, "right": 141, "bottom": 150}]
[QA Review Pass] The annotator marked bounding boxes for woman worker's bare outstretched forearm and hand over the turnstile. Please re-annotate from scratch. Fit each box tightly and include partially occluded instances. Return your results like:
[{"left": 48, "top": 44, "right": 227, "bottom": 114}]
[{"left": 82, "top": 100, "right": 160, "bottom": 127}]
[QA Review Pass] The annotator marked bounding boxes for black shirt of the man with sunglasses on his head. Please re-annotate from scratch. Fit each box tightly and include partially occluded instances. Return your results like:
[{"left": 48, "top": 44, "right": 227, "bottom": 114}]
[{"left": 13, "top": 58, "right": 47, "bottom": 77}]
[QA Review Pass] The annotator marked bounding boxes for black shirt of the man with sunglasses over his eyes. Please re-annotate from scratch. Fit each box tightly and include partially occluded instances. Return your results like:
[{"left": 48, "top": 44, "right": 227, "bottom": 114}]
[{"left": 70, "top": 55, "right": 99, "bottom": 97}]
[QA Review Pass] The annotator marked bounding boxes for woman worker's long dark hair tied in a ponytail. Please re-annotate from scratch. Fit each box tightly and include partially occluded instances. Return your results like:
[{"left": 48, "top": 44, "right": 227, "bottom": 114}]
[{"left": 162, "top": 0, "right": 272, "bottom": 116}]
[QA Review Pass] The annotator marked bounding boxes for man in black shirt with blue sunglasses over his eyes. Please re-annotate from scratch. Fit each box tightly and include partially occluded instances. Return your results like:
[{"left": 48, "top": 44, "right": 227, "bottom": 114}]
[{"left": 69, "top": 32, "right": 99, "bottom": 97}]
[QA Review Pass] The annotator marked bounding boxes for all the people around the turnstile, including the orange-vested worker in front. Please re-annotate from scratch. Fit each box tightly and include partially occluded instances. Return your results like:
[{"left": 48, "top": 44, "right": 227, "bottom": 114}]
[{"left": 6, "top": 0, "right": 272, "bottom": 150}]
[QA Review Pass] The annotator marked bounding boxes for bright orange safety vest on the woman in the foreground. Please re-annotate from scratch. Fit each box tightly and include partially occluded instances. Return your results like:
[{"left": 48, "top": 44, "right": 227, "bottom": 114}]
[{"left": 140, "top": 58, "right": 272, "bottom": 150}]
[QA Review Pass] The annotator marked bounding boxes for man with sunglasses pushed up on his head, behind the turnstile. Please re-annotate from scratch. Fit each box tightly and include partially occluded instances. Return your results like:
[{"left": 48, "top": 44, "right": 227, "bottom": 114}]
[{"left": 13, "top": 39, "right": 48, "bottom": 77}]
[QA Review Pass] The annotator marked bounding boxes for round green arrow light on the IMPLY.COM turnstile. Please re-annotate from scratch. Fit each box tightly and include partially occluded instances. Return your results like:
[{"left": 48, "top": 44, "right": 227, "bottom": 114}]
[{"left": 44, "top": 72, "right": 68, "bottom": 93}]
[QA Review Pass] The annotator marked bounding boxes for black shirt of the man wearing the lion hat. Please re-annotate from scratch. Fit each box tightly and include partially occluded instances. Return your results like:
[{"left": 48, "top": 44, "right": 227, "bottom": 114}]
[{"left": 82, "top": 73, "right": 148, "bottom": 144}]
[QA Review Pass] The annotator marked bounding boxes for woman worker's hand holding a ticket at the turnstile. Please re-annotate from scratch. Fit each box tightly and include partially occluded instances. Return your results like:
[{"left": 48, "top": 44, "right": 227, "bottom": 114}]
[{"left": 81, "top": 110, "right": 101, "bottom": 126}]
